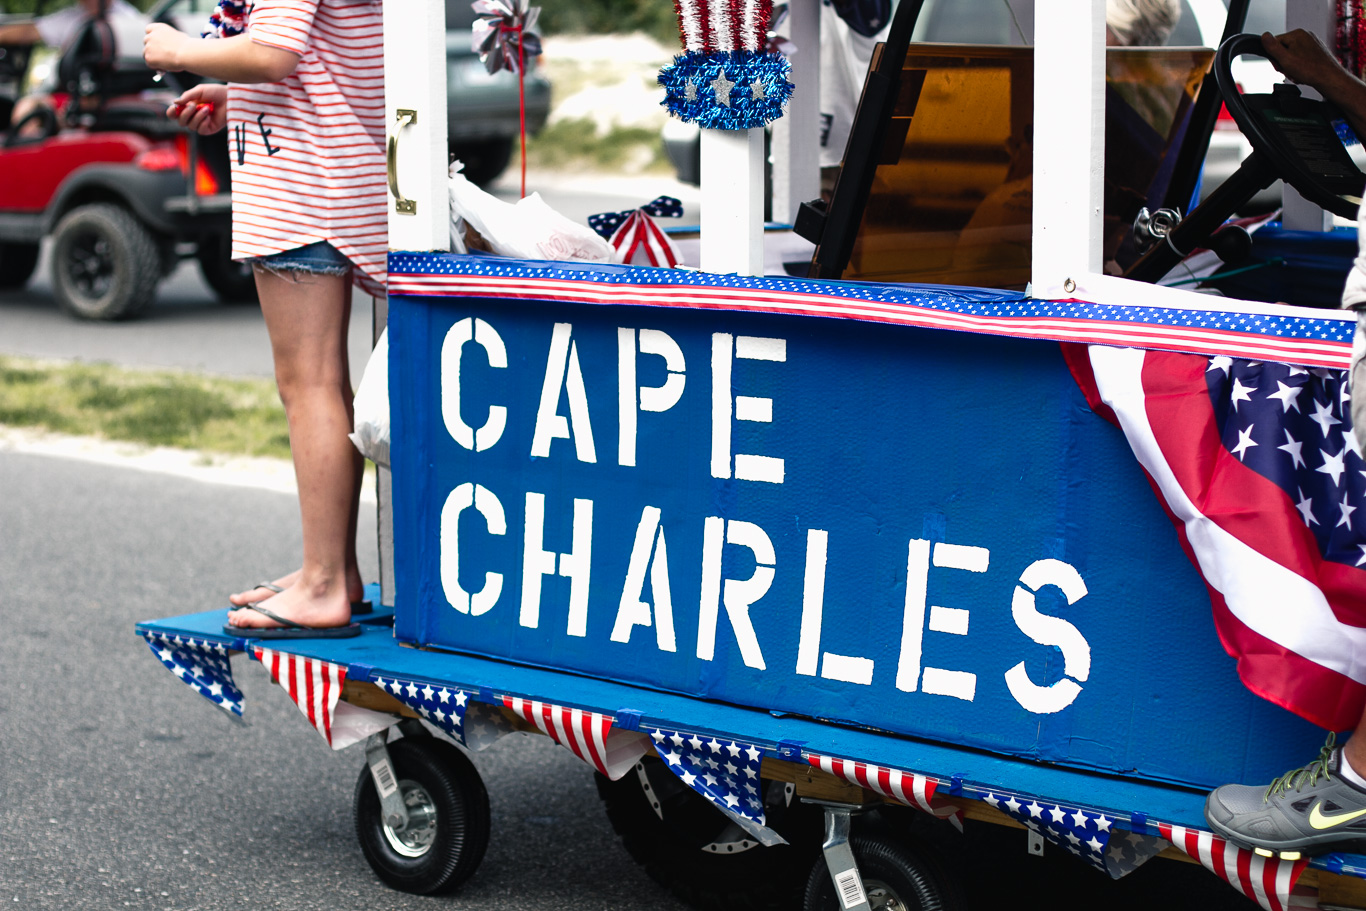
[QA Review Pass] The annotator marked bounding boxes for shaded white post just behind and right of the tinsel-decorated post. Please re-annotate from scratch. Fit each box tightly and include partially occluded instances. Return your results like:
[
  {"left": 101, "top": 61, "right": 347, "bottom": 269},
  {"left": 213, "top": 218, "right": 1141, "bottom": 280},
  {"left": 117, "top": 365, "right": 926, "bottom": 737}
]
[{"left": 772, "top": 0, "right": 821, "bottom": 224}]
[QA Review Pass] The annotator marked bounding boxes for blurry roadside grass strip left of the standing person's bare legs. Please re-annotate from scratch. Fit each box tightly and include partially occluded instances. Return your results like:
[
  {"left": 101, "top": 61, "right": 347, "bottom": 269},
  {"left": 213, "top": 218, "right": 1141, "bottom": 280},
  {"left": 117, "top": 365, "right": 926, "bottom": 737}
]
[{"left": 0, "top": 356, "right": 290, "bottom": 459}]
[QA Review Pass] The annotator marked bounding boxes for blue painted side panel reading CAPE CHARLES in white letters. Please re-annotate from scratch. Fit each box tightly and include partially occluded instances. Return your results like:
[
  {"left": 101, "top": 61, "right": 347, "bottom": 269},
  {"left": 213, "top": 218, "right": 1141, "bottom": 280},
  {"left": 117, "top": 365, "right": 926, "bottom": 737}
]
[{"left": 389, "top": 286, "right": 1321, "bottom": 787}]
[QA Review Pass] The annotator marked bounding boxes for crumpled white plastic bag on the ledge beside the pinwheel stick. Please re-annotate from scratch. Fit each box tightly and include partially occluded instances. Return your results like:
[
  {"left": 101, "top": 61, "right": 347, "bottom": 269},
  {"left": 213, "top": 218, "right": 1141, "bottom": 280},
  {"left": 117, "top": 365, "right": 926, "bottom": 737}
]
[{"left": 449, "top": 163, "right": 613, "bottom": 262}]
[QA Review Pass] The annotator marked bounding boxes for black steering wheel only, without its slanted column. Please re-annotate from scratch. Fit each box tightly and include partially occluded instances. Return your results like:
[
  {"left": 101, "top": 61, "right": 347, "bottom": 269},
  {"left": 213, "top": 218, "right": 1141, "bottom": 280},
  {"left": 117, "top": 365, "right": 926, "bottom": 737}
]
[{"left": 1214, "top": 34, "right": 1366, "bottom": 219}]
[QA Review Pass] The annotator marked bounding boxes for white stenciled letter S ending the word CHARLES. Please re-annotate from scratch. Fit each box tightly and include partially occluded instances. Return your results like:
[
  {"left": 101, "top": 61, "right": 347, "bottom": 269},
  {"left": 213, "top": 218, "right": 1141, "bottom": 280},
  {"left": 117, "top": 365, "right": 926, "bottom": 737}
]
[{"left": 1005, "top": 560, "right": 1091, "bottom": 714}]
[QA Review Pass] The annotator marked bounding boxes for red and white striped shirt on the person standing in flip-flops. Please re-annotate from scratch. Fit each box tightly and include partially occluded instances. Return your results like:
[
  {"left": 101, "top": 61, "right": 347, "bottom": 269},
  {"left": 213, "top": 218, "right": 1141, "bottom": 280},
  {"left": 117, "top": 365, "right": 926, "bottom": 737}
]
[{"left": 228, "top": 0, "right": 388, "bottom": 294}]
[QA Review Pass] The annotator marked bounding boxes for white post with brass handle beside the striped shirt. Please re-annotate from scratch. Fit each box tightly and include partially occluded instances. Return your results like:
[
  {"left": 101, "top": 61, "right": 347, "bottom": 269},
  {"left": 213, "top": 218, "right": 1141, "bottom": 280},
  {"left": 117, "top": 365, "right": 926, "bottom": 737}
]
[{"left": 384, "top": 0, "right": 451, "bottom": 251}]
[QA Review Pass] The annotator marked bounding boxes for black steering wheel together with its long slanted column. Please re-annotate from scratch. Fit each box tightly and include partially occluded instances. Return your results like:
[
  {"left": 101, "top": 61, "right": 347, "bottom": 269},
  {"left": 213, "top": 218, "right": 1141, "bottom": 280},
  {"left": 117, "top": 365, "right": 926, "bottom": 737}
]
[{"left": 1124, "top": 34, "right": 1366, "bottom": 281}]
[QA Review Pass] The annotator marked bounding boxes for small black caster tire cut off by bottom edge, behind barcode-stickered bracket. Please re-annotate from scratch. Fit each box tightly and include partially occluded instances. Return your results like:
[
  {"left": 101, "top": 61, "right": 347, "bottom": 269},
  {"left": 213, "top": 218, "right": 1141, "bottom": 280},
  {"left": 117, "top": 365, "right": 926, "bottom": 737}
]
[{"left": 802, "top": 835, "right": 963, "bottom": 911}]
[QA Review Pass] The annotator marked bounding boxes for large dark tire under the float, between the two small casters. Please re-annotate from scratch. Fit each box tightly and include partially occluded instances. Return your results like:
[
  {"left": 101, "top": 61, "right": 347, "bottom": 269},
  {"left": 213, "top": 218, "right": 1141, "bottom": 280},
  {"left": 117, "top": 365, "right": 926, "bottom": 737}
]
[{"left": 597, "top": 757, "right": 822, "bottom": 911}]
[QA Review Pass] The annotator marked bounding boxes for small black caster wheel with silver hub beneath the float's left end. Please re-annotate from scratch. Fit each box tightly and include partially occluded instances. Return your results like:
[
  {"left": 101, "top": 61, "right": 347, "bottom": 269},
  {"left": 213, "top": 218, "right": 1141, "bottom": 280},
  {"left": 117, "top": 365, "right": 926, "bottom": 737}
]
[{"left": 355, "top": 738, "right": 489, "bottom": 895}]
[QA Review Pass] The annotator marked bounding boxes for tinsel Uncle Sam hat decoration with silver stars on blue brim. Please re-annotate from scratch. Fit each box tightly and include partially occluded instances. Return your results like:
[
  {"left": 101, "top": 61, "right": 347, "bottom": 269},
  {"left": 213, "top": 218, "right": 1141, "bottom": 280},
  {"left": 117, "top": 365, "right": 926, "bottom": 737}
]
[{"left": 660, "top": 0, "right": 792, "bottom": 130}]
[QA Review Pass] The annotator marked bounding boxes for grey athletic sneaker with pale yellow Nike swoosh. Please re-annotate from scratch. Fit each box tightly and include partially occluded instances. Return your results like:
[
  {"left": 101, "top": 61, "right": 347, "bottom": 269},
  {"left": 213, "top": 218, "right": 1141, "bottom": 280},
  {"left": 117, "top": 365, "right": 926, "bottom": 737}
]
[{"left": 1205, "top": 733, "right": 1366, "bottom": 860}]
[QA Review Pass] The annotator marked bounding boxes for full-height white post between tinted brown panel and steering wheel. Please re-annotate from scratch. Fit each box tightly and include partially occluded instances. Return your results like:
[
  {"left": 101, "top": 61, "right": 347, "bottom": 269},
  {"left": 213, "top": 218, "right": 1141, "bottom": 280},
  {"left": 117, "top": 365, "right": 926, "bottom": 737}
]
[{"left": 1031, "top": 0, "right": 1105, "bottom": 298}]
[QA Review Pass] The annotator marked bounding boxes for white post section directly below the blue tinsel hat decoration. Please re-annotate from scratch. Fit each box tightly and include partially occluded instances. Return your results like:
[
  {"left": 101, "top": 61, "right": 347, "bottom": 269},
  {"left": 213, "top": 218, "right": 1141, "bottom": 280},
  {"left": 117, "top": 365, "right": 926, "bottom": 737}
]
[{"left": 701, "top": 128, "right": 764, "bottom": 276}]
